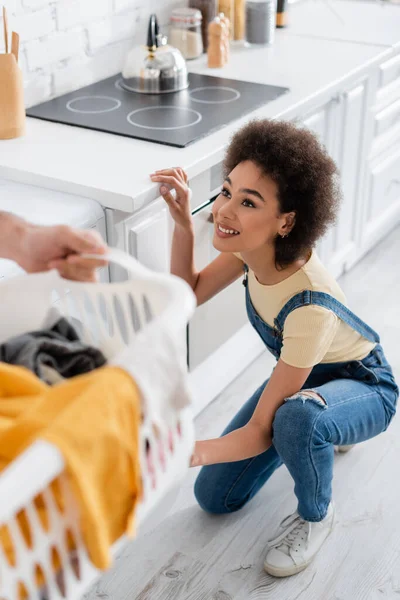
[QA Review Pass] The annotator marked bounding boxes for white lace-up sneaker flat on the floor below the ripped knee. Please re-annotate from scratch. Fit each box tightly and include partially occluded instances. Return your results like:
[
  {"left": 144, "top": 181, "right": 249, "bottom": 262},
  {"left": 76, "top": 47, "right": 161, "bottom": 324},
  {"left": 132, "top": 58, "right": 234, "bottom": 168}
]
[{"left": 264, "top": 502, "right": 335, "bottom": 577}]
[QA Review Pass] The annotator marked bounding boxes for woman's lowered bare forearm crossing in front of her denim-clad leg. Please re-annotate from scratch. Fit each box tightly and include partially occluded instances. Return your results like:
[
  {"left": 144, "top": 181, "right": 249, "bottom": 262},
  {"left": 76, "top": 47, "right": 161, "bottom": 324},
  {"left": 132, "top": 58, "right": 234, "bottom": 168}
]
[{"left": 192, "top": 423, "right": 272, "bottom": 466}]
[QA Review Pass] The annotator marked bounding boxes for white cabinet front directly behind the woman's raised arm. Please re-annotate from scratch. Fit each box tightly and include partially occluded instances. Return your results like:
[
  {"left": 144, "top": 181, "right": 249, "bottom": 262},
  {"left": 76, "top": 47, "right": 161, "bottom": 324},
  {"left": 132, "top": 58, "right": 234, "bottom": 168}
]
[{"left": 189, "top": 203, "right": 247, "bottom": 371}]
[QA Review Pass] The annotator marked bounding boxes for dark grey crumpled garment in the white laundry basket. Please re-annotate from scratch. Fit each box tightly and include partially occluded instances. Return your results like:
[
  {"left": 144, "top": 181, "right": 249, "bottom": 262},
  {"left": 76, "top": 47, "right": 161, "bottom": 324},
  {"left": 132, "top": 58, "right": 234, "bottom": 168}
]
[{"left": 0, "top": 318, "right": 106, "bottom": 384}]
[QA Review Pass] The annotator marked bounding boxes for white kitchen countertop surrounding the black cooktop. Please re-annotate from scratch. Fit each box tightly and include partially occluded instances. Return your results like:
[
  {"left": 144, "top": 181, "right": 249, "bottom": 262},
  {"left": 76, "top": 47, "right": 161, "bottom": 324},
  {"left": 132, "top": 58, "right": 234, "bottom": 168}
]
[{"left": 0, "top": 0, "right": 400, "bottom": 212}]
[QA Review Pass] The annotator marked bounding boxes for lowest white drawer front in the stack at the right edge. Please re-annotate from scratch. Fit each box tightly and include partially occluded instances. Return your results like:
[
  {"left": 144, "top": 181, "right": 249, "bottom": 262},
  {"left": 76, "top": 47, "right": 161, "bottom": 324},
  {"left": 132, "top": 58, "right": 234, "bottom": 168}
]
[{"left": 367, "top": 147, "right": 400, "bottom": 222}]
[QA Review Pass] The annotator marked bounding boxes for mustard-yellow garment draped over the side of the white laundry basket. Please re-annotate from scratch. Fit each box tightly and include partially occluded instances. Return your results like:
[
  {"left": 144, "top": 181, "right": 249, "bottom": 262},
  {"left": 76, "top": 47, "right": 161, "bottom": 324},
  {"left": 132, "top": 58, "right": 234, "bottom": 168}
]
[{"left": 0, "top": 363, "right": 142, "bottom": 569}]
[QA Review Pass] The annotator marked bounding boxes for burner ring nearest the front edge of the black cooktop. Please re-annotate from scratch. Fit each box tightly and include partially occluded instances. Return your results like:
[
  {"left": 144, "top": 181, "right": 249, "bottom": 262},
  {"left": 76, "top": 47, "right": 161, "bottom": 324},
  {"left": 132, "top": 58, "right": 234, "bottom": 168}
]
[{"left": 127, "top": 106, "right": 203, "bottom": 131}]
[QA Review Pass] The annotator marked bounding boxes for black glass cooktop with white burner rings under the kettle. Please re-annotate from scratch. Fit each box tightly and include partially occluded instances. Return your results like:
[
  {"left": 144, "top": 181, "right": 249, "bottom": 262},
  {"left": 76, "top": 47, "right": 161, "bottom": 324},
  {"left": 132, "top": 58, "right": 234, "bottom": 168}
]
[{"left": 27, "top": 73, "right": 289, "bottom": 148}]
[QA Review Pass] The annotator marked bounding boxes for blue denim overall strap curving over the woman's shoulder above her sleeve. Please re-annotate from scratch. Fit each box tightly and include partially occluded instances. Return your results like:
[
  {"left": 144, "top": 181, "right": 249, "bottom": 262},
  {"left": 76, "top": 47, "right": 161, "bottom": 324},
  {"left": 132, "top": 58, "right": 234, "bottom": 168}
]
[{"left": 274, "top": 290, "right": 380, "bottom": 344}]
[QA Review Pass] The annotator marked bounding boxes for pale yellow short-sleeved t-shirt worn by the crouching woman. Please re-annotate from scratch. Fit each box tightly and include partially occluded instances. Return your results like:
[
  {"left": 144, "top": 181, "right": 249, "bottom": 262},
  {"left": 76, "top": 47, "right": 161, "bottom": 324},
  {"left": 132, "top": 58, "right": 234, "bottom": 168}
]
[{"left": 234, "top": 252, "right": 376, "bottom": 368}]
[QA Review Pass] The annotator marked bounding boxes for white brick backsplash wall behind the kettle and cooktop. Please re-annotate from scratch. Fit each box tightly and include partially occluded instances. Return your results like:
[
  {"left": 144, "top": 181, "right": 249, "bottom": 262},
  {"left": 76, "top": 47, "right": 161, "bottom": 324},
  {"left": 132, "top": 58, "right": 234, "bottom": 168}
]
[{"left": 0, "top": 0, "right": 187, "bottom": 106}]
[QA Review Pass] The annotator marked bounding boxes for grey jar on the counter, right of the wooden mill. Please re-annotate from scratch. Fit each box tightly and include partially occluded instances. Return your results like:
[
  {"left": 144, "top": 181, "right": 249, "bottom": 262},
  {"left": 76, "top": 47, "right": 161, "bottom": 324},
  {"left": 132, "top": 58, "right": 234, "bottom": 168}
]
[{"left": 246, "top": 0, "right": 276, "bottom": 46}]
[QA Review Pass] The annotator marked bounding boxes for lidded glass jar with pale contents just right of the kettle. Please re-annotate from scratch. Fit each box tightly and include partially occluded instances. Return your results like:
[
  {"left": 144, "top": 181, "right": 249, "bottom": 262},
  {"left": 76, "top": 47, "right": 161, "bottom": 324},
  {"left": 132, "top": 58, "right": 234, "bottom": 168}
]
[{"left": 168, "top": 8, "right": 203, "bottom": 60}]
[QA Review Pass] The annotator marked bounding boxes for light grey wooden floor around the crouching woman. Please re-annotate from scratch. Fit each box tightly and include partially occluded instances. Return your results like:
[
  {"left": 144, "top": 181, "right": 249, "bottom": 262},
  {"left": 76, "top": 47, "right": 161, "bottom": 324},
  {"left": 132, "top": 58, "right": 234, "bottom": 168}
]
[{"left": 87, "top": 228, "right": 400, "bottom": 600}]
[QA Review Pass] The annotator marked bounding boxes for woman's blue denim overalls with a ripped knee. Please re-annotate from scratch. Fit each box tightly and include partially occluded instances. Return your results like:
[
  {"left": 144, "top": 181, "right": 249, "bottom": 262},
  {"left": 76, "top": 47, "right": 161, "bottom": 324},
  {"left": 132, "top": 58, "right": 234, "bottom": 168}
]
[{"left": 195, "top": 265, "right": 399, "bottom": 521}]
